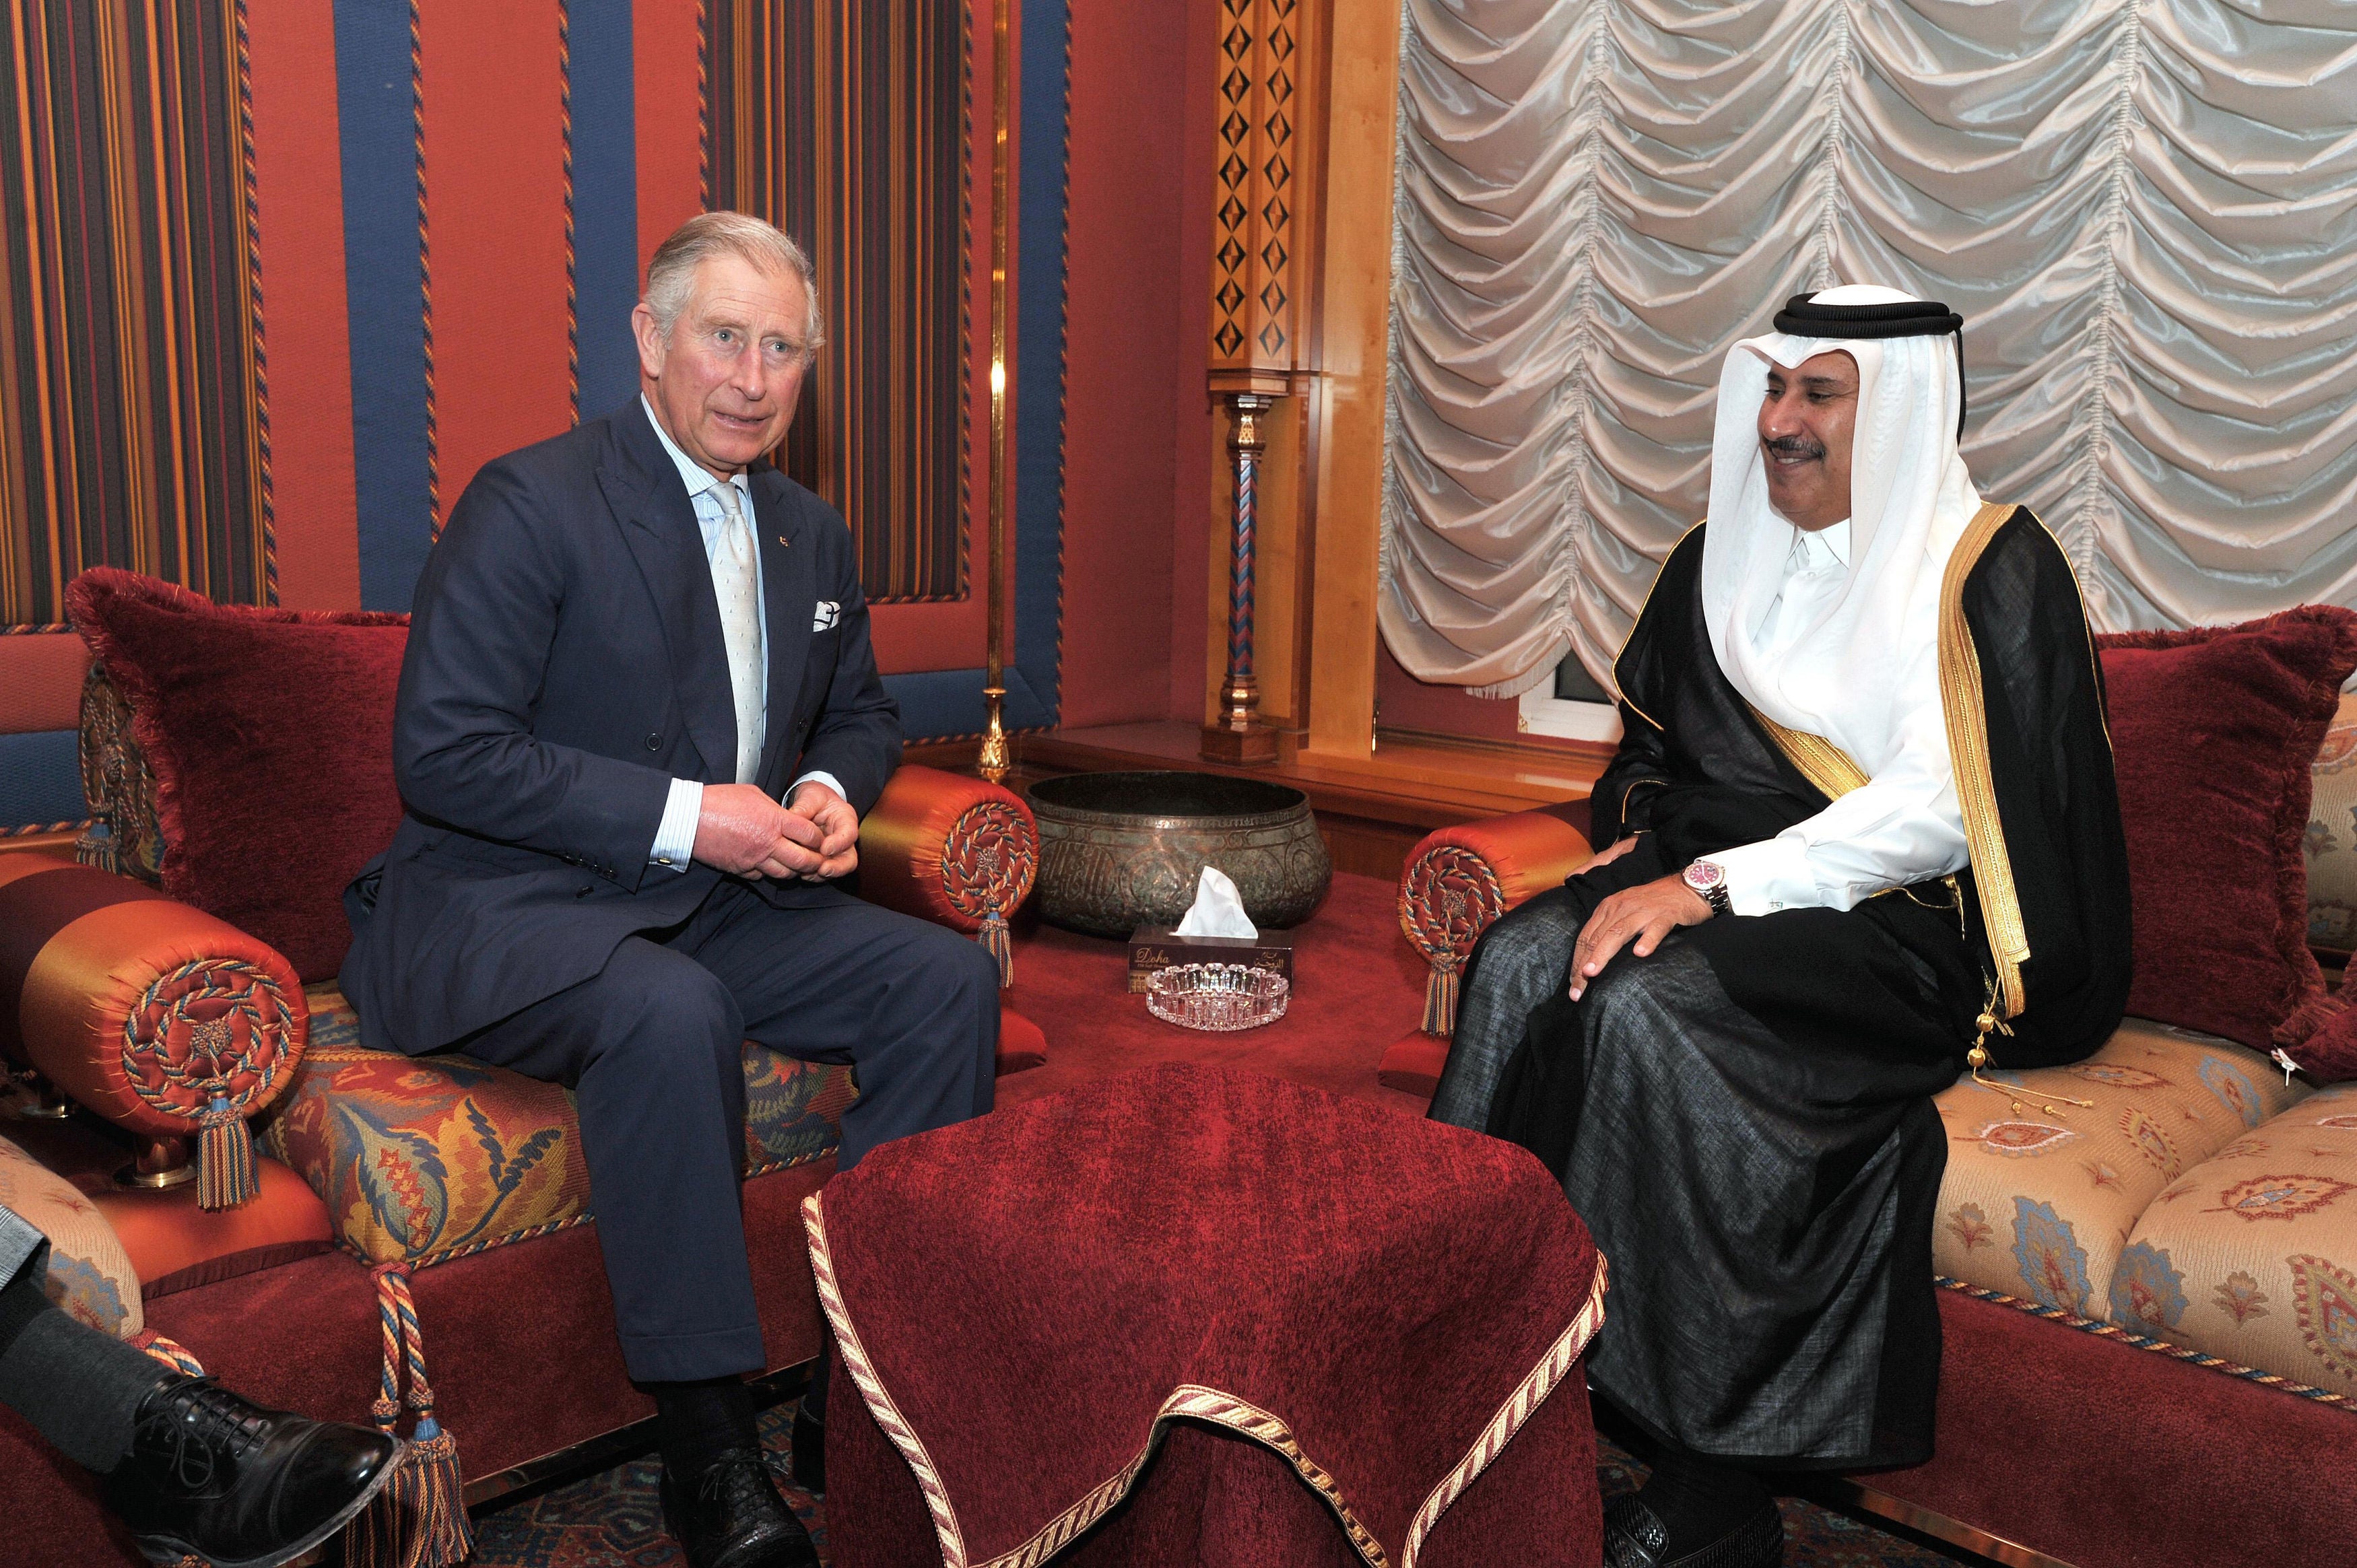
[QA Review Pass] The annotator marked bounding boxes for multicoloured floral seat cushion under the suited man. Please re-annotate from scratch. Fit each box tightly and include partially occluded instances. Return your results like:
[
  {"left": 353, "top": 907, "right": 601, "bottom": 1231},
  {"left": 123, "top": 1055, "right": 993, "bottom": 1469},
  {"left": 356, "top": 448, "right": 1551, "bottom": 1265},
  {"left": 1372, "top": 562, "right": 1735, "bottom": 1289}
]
[{"left": 262, "top": 986, "right": 853, "bottom": 1266}]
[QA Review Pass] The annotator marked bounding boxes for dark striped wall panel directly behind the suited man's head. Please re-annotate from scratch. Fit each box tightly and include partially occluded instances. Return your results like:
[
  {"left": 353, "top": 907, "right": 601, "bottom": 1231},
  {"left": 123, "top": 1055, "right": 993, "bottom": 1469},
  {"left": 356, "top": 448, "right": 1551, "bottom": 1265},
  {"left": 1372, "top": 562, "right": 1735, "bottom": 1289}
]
[{"left": 705, "top": 0, "right": 971, "bottom": 604}]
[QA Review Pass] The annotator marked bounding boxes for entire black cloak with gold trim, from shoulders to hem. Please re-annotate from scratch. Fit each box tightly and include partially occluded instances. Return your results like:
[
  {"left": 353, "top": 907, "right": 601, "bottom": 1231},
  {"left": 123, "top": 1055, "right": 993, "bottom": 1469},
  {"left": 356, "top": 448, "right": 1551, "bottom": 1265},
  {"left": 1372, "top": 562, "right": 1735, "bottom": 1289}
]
[{"left": 1490, "top": 507, "right": 2129, "bottom": 1469}]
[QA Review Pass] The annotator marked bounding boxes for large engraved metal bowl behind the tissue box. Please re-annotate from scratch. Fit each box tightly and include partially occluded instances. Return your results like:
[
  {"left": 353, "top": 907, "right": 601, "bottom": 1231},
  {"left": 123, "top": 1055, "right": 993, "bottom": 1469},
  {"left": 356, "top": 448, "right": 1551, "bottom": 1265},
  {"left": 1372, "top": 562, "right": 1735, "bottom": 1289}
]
[{"left": 1030, "top": 774, "right": 1334, "bottom": 936}]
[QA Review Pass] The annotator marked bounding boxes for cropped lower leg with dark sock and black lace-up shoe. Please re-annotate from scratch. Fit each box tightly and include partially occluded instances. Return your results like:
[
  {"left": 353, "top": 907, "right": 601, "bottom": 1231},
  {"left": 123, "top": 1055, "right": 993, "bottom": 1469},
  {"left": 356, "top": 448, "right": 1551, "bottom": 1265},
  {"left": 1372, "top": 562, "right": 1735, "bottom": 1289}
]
[{"left": 0, "top": 1207, "right": 401, "bottom": 1568}]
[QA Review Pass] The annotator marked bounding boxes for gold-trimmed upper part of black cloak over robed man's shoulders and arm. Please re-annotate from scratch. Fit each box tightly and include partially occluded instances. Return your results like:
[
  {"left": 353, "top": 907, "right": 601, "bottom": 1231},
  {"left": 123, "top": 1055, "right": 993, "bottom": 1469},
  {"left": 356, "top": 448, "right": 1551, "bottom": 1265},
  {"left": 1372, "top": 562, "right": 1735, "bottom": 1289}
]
[{"left": 1591, "top": 504, "right": 2131, "bottom": 1068}]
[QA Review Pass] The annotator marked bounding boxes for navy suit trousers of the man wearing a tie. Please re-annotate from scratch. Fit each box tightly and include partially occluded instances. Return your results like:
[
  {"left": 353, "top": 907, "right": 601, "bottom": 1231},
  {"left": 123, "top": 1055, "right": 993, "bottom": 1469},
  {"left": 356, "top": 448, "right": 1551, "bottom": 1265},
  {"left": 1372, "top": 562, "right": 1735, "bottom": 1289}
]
[{"left": 455, "top": 870, "right": 999, "bottom": 1382}]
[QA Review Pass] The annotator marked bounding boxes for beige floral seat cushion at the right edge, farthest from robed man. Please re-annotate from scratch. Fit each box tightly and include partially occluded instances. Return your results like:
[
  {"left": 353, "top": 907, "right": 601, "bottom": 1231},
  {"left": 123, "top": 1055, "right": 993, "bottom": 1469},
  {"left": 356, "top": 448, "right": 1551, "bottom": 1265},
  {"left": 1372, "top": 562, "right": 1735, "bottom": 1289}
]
[{"left": 2096, "top": 1085, "right": 2357, "bottom": 1394}]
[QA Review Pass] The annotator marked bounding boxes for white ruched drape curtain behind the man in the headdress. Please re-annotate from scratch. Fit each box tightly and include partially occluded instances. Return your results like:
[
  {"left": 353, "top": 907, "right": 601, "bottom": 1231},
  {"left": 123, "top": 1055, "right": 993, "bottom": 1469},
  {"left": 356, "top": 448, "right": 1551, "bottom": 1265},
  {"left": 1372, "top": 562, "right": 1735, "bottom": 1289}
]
[{"left": 1381, "top": 0, "right": 2357, "bottom": 695}]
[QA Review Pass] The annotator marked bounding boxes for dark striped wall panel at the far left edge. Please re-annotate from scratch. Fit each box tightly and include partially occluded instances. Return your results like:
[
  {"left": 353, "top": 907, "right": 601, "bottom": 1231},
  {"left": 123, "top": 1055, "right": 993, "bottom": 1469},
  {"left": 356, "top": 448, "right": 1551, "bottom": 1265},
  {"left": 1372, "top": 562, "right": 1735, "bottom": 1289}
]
[{"left": 0, "top": 0, "right": 276, "bottom": 627}]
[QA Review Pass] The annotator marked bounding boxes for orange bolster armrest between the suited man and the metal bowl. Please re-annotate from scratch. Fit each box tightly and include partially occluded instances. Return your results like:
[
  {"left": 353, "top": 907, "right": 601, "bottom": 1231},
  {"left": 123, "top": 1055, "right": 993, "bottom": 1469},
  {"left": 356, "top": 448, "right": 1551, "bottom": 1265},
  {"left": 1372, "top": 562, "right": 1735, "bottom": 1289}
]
[{"left": 861, "top": 766, "right": 1040, "bottom": 931}]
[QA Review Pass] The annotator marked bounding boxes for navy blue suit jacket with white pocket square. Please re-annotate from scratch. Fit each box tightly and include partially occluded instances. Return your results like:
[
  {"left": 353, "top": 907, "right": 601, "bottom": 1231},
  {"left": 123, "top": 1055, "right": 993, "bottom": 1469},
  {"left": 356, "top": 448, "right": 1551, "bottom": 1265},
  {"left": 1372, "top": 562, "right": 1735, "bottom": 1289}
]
[{"left": 342, "top": 399, "right": 900, "bottom": 1054}]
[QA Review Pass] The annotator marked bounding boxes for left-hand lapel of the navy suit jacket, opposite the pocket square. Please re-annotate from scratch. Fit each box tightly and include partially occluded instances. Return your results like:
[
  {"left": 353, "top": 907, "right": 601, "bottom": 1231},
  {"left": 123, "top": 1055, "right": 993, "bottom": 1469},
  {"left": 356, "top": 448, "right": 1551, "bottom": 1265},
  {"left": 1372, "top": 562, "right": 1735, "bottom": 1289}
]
[{"left": 597, "top": 401, "right": 735, "bottom": 783}]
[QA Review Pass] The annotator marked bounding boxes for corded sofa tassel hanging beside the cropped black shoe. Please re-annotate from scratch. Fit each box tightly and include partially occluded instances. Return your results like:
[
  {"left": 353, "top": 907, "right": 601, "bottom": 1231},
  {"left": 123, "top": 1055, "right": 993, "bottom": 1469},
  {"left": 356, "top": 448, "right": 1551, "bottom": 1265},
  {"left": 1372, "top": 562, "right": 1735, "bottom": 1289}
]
[{"left": 344, "top": 1264, "right": 474, "bottom": 1568}]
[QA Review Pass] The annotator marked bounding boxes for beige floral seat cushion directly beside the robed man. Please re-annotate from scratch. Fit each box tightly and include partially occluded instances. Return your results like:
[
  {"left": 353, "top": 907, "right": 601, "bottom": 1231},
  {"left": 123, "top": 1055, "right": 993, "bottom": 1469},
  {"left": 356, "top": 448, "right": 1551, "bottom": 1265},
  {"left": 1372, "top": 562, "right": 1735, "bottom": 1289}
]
[{"left": 1933, "top": 1019, "right": 2310, "bottom": 1318}]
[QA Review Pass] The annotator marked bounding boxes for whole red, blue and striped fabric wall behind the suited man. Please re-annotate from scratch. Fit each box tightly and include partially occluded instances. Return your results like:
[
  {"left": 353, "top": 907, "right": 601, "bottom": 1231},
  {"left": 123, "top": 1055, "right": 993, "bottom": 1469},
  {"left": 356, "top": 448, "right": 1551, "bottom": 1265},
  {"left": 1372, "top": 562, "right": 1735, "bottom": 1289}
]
[{"left": 0, "top": 0, "right": 1068, "bottom": 832}]
